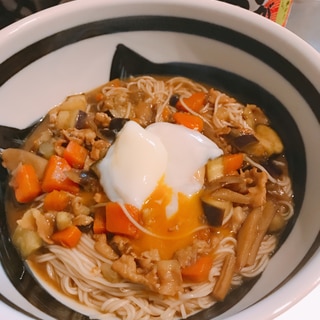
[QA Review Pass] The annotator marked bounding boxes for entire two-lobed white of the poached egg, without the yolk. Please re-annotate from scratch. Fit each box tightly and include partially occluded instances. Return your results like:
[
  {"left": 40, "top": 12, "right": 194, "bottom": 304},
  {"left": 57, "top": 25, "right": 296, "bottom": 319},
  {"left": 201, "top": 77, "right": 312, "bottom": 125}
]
[{"left": 98, "top": 121, "right": 222, "bottom": 218}]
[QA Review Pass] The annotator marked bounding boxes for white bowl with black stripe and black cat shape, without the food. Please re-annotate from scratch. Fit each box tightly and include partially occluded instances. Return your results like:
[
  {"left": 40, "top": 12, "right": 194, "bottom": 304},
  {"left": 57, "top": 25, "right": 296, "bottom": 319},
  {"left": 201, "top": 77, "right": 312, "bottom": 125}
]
[{"left": 0, "top": 0, "right": 320, "bottom": 319}]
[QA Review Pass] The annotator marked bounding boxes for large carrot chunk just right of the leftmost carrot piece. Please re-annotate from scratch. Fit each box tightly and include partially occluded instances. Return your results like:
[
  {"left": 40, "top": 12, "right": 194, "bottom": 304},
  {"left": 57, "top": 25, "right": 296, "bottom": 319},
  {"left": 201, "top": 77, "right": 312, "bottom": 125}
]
[{"left": 42, "top": 155, "right": 79, "bottom": 193}]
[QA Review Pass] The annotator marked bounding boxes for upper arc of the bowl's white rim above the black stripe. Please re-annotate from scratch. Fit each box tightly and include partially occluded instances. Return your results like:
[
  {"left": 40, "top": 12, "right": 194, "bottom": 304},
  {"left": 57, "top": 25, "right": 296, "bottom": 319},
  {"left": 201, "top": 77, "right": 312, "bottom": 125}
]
[{"left": 0, "top": 0, "right": 320, "bottom": 91}]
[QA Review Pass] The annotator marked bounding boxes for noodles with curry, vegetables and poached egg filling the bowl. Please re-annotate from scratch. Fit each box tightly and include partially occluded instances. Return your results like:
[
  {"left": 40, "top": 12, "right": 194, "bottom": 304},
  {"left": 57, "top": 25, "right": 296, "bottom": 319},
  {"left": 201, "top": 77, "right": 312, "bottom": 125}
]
[{"left": 2, "top": 75, "right": 293, "bottom": 319}]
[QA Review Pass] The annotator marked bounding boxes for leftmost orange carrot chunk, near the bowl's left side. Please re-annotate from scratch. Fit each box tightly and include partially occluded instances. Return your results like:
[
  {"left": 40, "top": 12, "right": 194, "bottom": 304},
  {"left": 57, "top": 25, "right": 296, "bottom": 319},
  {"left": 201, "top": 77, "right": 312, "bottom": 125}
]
[{"left": 12, "top": 164, "right": 41, "bottom": 203}]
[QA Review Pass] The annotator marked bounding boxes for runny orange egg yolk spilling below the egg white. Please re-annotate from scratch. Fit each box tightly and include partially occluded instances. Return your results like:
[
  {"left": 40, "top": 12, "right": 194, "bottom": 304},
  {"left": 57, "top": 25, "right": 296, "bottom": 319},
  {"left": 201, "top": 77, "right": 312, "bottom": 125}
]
[{"left": 132, "top": 179, "right": 204, "bottom": 259}]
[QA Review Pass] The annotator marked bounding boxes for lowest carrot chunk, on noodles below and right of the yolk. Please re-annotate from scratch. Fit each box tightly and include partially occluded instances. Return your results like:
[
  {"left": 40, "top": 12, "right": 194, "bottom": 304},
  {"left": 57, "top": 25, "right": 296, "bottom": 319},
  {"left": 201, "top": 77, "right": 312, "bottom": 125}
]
[{"left": 181, "top": 256, "right": 213, "bottom": 282}]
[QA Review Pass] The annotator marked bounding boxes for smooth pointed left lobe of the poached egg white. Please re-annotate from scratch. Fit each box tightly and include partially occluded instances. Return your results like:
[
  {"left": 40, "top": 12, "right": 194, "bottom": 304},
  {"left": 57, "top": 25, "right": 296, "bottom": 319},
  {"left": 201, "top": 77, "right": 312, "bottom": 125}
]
[{"left": 97, "top": 121, "right": 168, "bottom": 208}]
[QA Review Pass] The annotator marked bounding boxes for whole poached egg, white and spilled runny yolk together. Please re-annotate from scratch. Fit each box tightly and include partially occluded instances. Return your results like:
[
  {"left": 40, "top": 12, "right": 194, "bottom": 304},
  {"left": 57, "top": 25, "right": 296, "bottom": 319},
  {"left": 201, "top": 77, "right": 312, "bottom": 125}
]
[{"left": 97, "top": 121, "right": 222, "bottom": 259}]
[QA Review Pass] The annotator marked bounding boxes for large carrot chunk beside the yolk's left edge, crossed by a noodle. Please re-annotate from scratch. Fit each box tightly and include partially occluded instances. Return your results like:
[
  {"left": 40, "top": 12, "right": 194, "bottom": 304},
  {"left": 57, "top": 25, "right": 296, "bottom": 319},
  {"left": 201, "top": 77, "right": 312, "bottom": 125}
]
[{"left": 106, "top": 202, "right": 140, "bottom": 237}]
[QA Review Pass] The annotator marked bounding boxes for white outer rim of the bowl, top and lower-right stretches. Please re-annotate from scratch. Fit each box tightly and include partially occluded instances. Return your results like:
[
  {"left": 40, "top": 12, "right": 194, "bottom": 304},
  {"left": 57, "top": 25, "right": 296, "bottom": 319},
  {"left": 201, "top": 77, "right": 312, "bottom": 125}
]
[{"left": 0, "top": 0, "right": 320, "bottom": 319}]
